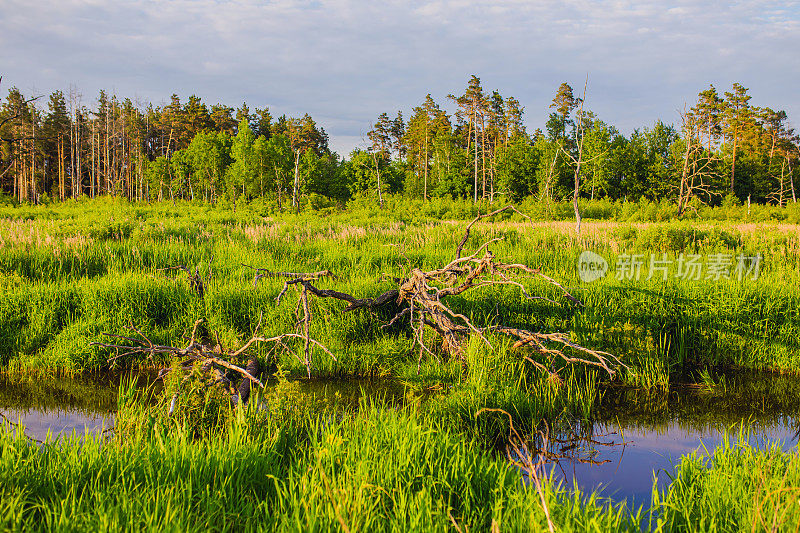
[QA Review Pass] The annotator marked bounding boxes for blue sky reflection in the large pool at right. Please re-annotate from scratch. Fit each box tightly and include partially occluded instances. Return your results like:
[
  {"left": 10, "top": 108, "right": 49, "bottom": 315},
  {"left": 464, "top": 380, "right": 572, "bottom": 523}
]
[{"left": 546, "top": 420, "right": 797, "bottom": 506}]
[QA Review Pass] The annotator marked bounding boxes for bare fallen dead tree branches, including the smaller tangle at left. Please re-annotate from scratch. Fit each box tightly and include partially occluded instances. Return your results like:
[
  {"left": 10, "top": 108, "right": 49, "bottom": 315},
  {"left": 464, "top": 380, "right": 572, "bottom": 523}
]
[{"left": 92, "top": 206, "right": 624, "bottom": 414}]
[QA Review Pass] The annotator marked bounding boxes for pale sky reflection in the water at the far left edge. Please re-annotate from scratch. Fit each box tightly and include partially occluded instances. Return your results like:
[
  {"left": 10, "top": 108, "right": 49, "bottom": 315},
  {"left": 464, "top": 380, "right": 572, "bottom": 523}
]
[{"left": 0, "top": 407, "right": 114, "bottom": 440}]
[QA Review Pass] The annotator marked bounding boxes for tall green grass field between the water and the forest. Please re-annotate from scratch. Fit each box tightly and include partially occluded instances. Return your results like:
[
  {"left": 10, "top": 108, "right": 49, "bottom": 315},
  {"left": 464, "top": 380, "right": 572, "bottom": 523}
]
[{"left": 0, "top": 199, "right": 800, "bottom": 389}]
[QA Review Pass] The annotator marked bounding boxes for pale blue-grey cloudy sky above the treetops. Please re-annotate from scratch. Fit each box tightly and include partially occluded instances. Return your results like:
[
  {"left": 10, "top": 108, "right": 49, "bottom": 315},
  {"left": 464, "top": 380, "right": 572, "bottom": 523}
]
[{"left": 0, "top": 0, "right": 800, "bottom": 155}]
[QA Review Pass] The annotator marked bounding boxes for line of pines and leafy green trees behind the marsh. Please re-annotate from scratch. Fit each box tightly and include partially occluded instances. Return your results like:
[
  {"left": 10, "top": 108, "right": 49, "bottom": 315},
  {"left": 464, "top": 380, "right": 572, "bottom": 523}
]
[{"left": 0, "top": 76, "right": 800, "bottom": 208}]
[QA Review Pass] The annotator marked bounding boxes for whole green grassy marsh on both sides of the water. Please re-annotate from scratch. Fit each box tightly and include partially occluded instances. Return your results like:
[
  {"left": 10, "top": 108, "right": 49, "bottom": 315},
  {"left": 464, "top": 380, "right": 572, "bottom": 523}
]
[{"left": 0, "top": 197, "right": 800, "bottom": 531}]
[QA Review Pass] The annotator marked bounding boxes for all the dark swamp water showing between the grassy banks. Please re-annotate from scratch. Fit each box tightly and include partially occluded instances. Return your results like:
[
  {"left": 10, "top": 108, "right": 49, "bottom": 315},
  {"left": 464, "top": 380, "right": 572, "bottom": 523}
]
[{"left": 0, "top": 372, "right": 800, "bottom": 506}]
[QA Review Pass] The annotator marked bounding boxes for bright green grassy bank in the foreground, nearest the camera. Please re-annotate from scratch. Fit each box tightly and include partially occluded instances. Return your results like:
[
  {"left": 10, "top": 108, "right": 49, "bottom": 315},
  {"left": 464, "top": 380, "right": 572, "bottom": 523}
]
[{"left": 0, "top": 398, "right": 800, "bottom": 531}]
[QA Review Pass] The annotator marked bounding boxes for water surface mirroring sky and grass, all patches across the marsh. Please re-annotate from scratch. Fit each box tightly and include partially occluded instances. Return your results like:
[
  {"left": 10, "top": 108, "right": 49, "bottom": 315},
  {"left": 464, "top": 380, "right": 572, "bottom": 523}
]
[{"left": 6, "top": 374, "right": 800, "bottom": 506}]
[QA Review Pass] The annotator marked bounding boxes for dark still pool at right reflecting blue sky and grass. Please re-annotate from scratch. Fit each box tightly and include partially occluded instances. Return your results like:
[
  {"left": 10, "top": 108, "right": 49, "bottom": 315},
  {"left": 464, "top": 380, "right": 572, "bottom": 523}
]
[{"left": 546, "top": 373, "right": 800, "bottom": 506}]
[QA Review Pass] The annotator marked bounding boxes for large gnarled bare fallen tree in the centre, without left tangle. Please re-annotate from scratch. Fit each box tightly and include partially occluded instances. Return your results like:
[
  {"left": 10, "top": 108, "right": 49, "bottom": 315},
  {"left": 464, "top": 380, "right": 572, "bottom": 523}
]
[{"left": 243, "top": 206, "right": 622, "bottom": 378}]
